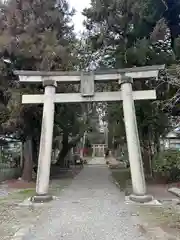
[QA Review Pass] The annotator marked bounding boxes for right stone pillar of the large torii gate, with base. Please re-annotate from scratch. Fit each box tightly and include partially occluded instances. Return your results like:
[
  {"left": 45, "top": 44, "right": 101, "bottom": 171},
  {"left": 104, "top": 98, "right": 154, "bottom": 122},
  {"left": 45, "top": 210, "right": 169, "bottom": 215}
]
[{"left": 120, "top": 76, "right": 153, "bottom": 203}]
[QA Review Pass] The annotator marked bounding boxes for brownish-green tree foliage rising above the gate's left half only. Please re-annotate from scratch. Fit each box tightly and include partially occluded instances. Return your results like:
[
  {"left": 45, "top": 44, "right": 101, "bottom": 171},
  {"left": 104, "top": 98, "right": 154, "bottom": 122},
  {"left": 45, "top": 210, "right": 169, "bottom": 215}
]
[{"left": 0, "top": 0, "right": 75, "bottom": 70}]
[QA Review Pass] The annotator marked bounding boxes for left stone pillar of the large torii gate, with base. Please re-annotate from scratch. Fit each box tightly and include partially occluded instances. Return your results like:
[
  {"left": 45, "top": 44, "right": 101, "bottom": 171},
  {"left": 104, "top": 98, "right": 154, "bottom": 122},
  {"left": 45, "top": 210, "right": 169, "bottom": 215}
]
[{"left": 32, "top": 79, "right": 57, "bottom": 202}]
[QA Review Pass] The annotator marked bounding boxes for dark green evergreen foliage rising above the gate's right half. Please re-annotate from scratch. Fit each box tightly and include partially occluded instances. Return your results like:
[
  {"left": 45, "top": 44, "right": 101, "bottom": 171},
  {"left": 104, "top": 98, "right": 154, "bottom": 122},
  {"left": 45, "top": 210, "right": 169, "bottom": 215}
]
[{"left": 84, "top": 0, "right": 174, "bottom": 68}]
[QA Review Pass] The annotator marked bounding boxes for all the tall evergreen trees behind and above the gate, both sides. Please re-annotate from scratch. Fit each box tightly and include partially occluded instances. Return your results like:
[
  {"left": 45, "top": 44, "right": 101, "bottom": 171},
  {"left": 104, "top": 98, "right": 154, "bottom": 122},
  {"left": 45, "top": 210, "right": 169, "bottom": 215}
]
[{"left": 0, "top": 0, "right": 180, "bottom": 180}]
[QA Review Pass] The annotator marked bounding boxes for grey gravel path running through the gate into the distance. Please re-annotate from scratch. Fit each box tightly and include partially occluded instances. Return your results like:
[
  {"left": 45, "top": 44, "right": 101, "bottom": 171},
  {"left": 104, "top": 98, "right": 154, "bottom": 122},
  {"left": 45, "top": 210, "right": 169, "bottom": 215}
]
[{"left": 23, "top": 159, "right": 146, "bottom": 240}]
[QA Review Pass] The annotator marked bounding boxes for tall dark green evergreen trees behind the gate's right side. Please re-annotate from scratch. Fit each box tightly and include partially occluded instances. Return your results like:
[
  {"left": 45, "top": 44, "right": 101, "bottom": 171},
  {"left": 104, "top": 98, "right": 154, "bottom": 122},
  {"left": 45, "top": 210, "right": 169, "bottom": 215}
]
[{"left": 84, "top": 0, "right": 180, "bottom": 172}]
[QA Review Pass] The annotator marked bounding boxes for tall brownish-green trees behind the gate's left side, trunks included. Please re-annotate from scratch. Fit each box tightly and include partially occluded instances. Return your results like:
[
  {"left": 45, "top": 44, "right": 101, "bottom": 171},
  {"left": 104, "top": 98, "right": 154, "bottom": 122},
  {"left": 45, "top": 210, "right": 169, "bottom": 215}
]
[{"left": 0, "top": 0, "right": 88, "bottom": 180}]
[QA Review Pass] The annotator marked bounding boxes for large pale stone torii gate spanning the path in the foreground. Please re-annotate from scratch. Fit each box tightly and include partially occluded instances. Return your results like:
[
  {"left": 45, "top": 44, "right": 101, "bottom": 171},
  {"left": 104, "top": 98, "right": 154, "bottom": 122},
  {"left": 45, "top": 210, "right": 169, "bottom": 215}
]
[{"left": 15, "top": 65, "right": 164, "bottom": 202}]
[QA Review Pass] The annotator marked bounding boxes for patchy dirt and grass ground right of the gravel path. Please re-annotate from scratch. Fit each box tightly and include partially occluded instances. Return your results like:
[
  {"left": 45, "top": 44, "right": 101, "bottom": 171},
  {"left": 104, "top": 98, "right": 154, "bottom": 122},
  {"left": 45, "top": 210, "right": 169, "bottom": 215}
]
[{"left": 112, "top": 169, "right": 180, "bottom": 240}]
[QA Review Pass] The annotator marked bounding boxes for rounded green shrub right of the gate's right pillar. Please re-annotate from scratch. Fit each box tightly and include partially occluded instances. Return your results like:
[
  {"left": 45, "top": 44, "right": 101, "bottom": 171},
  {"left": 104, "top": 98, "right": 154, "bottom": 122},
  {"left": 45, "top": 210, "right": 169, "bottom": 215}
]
[{"left": 153, "top": 150, "right": 180, "bottom": 182}]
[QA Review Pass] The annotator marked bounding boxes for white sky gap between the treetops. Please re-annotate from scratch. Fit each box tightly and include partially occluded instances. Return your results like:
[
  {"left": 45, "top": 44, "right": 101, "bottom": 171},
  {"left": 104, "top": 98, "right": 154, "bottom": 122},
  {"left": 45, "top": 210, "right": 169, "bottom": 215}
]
[{"left": 69, "top": 0, "right": 90, "bottom": 33}]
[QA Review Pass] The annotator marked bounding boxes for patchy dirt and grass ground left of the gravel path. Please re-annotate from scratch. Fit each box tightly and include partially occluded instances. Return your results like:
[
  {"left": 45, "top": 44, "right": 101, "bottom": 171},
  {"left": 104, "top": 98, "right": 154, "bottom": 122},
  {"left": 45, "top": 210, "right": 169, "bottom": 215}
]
[{"left": 0, "top": 168, "right": 80, "bottom": 240}]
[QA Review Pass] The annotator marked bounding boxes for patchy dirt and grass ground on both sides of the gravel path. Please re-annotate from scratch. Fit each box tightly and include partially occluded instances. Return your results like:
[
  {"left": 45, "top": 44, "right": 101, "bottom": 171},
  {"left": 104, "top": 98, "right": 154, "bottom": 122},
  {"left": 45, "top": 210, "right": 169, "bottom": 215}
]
[{"left": 0, "top": 165, "right": 180, "bottom": 240}]
